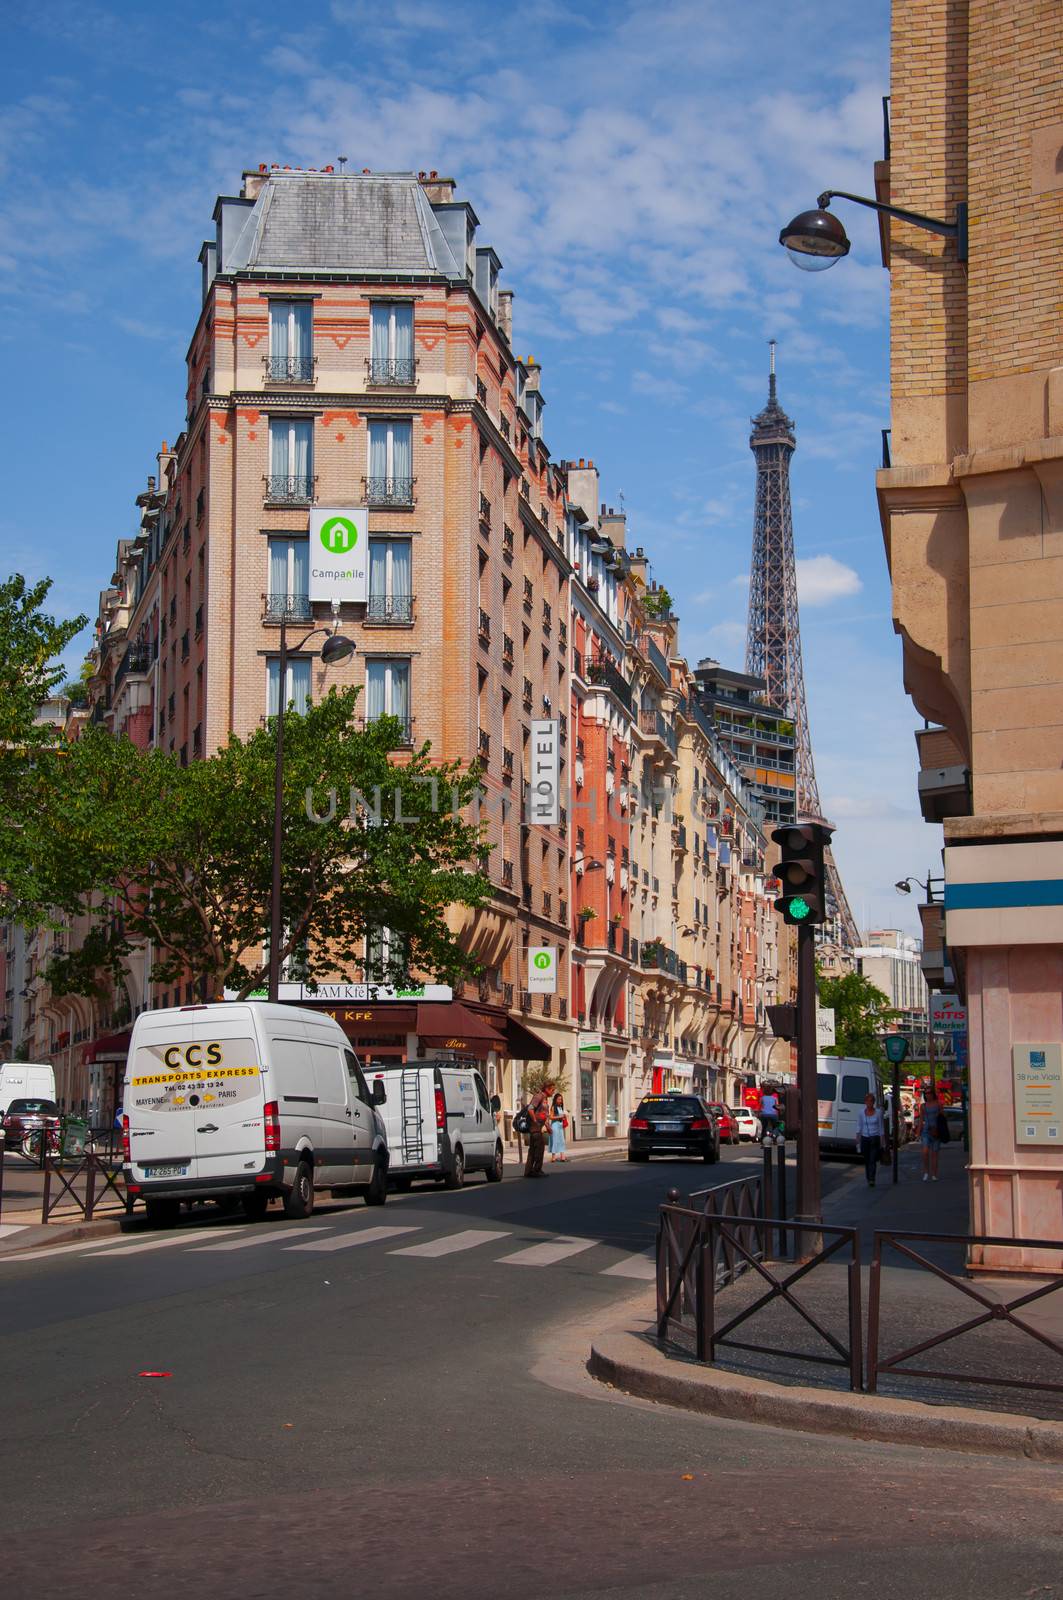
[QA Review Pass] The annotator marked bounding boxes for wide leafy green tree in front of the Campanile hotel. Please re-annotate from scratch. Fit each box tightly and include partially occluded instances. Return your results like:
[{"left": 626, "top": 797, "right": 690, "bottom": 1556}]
[{"left": 17, "top": 690, "right": 487, "bottom": 995}]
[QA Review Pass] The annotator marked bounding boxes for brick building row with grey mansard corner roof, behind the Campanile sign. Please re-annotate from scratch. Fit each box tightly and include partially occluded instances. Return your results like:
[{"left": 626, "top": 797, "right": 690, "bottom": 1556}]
[{"left": 6, "top": 168, "right": 788, "bottom": 1136}]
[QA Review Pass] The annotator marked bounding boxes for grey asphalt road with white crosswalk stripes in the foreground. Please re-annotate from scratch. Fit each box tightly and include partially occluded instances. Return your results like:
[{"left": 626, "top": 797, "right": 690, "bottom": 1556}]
[{"left": 0, "top": 1152, "right": 1063, "bottom": 1600}]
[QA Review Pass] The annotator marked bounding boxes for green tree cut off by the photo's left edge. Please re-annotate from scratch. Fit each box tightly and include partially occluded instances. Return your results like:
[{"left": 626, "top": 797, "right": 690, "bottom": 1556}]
[{"left": 0, "top": 573, "right": 88, "bottom": 914}]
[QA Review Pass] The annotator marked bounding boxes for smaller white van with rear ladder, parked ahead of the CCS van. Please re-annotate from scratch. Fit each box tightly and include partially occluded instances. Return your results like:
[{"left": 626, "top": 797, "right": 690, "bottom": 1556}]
[{"left": 368, "top": 1061, "right": 503, "bottom": 1189}]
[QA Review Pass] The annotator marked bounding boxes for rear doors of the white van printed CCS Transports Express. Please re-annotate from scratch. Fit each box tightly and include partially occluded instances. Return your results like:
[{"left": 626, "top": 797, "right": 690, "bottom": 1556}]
[{"left": 125, "top": 1013, "right": 266, "bottom": 1182}]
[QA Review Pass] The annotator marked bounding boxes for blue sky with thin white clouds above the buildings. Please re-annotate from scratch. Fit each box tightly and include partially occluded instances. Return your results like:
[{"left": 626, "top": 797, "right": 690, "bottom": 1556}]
[{"left": 0, "top": 0, "right": 938, "bottom": 928}]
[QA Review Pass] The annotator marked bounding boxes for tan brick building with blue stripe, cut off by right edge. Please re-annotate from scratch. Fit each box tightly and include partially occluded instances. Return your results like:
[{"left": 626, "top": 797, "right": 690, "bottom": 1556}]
[{"left": 876, "top": 0, "right": 1063, "bottom": 1270}]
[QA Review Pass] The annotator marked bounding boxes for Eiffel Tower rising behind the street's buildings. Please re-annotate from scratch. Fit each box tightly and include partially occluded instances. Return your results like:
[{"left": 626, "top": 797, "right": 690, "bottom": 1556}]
[{"left": 746, "top": 339, "right": 860, "bottom": 949}]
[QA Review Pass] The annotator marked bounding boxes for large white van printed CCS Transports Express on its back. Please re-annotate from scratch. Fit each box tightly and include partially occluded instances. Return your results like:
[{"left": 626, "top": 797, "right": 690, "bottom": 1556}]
[{"left": 123, "top": 1002, "right": 387, "bottom": 1224}]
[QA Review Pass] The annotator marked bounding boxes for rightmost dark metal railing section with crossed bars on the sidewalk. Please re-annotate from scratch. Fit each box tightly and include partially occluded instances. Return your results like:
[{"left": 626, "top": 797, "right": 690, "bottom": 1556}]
[{"left": 868, "top": 1229, "right": 1063, "bottom": 1394}]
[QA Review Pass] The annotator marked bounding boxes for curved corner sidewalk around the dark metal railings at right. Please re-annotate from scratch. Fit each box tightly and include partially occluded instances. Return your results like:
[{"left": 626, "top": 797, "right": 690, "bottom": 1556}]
[{"left": 591, "top": 1146, "right": 1063, "bottom": 1459}]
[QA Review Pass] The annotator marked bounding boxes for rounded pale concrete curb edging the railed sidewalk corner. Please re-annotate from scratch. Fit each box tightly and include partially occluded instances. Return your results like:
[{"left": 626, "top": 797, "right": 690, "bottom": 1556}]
[{"left": 588, "top": 1323, "right": 1063, "bottom": 1462}]
